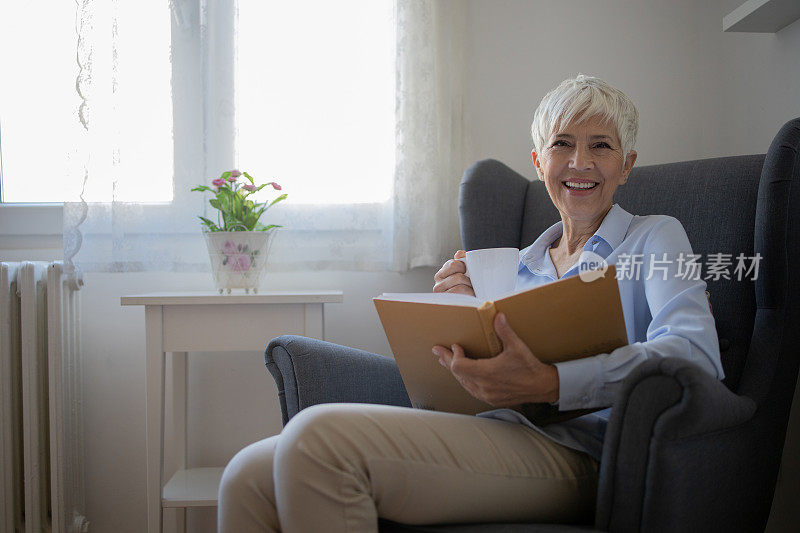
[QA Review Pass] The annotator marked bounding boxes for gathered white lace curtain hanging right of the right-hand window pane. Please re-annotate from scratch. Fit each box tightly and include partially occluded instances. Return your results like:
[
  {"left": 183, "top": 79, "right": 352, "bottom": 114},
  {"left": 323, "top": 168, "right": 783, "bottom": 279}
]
[{"left": 393, "top": 0, "right": 466, "bottom": 271}]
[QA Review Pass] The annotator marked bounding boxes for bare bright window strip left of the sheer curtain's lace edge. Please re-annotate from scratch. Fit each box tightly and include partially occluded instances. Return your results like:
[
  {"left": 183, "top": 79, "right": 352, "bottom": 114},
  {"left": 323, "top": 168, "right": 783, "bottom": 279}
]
[{"left": 0, "top": 2, "right": 80, "bottom": 203}]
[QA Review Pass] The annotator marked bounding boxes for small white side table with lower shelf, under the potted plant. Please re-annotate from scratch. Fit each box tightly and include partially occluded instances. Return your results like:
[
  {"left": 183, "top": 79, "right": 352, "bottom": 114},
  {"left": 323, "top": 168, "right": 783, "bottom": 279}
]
[{"left": 121, "top": 290, "right": 342, "bottom": 533}]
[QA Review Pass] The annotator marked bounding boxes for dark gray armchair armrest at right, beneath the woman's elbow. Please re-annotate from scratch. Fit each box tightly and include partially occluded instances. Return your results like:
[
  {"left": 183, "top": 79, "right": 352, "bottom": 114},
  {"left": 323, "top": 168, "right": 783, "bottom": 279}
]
[{"left": 596, "top": 358, "right": 765, "bottom": 531}]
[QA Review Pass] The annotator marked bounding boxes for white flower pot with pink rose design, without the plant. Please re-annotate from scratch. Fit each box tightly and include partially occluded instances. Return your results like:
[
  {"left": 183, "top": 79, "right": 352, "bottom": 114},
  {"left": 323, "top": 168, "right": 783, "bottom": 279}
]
[{"left": 203, "top": 228, "right": 277, "bottom": 294}]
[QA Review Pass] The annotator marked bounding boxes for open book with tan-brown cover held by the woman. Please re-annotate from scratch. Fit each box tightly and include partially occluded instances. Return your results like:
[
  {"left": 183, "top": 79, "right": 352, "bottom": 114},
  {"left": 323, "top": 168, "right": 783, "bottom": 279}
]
[{"left": 373, "top": 265, "right": 628, "bottom": 425}]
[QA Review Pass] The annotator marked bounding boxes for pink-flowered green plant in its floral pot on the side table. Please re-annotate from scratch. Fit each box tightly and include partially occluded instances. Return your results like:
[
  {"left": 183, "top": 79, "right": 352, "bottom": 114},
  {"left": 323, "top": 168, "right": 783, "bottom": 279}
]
[{"left": 192, "top": 170, "right": 286, "bottom": 294}]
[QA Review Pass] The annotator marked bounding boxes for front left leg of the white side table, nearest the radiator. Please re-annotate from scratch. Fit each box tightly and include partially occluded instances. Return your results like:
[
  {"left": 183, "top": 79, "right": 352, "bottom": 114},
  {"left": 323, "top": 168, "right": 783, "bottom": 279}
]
[{"left": 145, "top": 305, "right": 165, "bottom": 533}]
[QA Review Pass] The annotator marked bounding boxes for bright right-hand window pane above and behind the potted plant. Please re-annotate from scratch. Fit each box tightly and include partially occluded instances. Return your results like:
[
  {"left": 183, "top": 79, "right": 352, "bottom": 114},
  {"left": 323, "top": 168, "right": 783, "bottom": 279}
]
[{"left": 235, "top": 0, "right": 395, "bottom": 206}]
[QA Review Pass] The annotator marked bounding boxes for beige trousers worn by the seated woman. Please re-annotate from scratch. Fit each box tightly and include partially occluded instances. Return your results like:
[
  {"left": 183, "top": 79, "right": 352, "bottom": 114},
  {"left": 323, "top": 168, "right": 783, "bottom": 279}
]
[{"left": 218, "top": 404, "right": 598, "bottom": 533}]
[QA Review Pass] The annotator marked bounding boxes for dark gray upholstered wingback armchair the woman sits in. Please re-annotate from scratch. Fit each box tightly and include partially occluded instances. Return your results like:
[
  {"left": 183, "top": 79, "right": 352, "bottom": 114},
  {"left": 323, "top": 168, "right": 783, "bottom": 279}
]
[{"left": 266, "top": 119, "right": 800, "bottom": 533}]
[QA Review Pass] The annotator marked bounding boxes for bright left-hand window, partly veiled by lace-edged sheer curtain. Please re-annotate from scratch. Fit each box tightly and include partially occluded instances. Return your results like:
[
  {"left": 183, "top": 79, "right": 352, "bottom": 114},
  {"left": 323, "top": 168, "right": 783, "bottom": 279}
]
[{"left": 0, "top": 1, "right": 173, "bottom": 203}]
